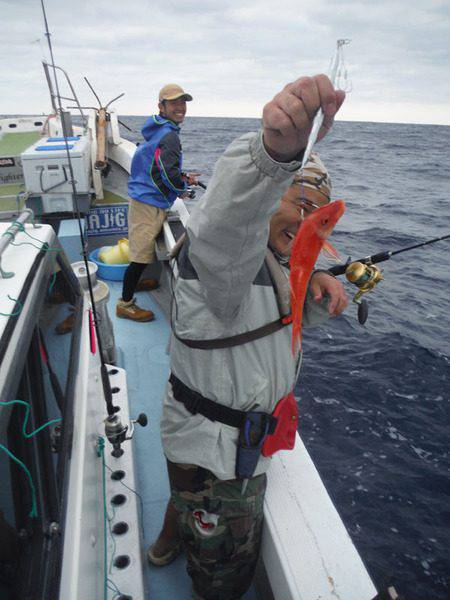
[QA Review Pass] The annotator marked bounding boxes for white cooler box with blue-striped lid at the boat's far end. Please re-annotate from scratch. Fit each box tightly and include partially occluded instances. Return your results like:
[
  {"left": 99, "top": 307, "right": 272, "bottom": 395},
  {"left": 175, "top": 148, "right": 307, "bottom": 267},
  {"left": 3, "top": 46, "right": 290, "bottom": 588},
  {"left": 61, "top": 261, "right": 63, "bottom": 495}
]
[{"left": 21, "top": 136, "right": 91, "bottom": 213}]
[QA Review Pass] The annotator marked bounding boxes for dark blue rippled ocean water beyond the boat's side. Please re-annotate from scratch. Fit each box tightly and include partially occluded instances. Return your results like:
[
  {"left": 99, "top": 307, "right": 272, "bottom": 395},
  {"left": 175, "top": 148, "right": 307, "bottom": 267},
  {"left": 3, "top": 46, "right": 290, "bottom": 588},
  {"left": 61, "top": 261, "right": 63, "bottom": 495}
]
[{"left": 122, "top": 117, "right": 450, "bottom": 600}]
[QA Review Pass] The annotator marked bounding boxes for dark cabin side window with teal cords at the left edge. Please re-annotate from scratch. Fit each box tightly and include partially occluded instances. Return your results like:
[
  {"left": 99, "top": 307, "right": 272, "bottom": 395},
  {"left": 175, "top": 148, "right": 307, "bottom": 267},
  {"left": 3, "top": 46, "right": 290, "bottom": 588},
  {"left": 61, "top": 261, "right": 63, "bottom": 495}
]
[{"left": 0, "top": 255, "right": 81, "bottom": 600}]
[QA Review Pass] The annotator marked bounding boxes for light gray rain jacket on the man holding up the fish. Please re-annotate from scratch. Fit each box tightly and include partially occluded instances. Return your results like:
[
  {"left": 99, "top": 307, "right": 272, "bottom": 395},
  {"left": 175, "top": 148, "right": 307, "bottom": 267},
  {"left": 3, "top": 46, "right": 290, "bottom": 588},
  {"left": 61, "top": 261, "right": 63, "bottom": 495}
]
[{"left": 161, "top": 133, "right": 328, "bottom": 479}]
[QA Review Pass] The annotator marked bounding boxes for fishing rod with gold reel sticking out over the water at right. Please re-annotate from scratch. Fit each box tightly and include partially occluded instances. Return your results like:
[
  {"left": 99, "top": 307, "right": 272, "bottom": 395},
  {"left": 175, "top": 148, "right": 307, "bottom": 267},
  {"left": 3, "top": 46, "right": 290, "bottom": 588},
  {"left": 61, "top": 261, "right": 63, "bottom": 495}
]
[{"left": 328, "top": 233, "right": 450, "bottom": 325}]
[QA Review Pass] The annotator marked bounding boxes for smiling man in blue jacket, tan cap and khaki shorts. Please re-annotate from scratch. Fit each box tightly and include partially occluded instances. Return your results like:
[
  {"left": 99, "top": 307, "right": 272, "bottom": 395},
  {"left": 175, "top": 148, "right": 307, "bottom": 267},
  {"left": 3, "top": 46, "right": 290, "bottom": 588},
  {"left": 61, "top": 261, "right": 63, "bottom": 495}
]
[{"left": 116, "top": 83, "right": 197, "bottom": 322}]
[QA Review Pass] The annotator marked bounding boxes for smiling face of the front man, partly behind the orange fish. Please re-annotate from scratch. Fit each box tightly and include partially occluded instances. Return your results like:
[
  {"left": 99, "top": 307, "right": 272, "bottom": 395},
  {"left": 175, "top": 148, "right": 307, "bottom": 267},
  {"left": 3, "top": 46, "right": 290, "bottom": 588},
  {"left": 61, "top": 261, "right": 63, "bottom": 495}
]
[{"left": 269, "top": 183, "right": 330, "bottom": 256}]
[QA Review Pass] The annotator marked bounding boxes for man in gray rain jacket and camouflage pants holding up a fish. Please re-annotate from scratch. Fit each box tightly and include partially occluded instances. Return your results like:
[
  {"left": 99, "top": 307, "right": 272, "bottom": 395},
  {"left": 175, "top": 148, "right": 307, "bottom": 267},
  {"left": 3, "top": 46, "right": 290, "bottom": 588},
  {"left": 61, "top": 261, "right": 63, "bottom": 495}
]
[{"left": 148, "top": 75, "right": 347, "bottom": 600}]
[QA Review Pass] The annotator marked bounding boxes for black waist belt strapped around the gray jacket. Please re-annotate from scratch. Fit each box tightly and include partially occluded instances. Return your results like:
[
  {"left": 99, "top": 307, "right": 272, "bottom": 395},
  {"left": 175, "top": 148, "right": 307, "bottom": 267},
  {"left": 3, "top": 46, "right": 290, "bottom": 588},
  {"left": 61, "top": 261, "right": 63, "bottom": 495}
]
[{"left": 169, "top": 373, "right": 277, "bottom": 433}]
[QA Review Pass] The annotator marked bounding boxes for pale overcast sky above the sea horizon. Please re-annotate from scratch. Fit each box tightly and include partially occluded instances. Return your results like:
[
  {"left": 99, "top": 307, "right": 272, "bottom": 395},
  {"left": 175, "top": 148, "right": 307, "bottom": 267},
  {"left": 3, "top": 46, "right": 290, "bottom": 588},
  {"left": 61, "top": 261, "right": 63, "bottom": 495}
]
[{"left": 0, "top": 0, "right": 450, "bottom": 125}]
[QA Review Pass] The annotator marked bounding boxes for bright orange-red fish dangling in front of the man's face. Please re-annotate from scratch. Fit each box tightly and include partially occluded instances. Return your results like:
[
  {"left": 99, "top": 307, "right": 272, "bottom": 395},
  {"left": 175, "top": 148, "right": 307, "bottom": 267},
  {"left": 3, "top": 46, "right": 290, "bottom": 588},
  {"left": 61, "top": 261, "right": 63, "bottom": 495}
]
[{"left": 289, "top": 200, "right": 345, "bottom": 354}]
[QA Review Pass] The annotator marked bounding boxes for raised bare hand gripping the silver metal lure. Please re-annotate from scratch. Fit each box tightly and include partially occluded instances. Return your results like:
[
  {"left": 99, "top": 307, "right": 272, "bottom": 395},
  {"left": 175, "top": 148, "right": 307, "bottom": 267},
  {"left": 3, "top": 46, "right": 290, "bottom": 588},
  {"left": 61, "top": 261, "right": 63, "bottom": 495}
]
[{"left": 263, "top": 75, "right": 345, "bottom": 162}]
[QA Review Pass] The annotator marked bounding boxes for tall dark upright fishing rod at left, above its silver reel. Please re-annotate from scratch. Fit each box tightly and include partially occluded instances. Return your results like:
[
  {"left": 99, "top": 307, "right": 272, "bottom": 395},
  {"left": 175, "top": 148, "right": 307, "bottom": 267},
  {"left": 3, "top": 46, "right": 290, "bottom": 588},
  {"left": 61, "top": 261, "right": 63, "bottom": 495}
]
[{"left": 41, "top": 0, "right": 120, "bottom": 419}]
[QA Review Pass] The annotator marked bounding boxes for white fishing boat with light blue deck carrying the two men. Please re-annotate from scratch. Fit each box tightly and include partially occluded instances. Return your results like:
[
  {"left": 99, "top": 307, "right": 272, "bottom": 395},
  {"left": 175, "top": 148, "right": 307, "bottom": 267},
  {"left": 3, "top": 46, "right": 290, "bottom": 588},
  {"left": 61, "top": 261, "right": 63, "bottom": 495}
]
[{"left": 0, "top": 55, "right": 388, "bottom": 600}]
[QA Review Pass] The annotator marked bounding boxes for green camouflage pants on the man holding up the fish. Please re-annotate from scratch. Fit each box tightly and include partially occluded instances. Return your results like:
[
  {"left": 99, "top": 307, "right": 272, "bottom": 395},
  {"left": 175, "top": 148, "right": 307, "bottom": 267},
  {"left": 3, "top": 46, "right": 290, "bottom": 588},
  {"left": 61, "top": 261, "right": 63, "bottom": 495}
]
[{"left": 167, "top": 461, "right": 266, "bottom": 600}]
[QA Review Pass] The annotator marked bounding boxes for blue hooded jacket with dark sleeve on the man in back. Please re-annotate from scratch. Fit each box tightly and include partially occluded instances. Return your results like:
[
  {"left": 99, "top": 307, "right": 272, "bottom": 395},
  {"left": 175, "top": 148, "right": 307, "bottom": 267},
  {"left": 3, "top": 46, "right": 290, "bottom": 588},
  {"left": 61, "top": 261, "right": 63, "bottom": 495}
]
[{"left": 128, "top": 115, "right": 187, "bottom": 208}]
